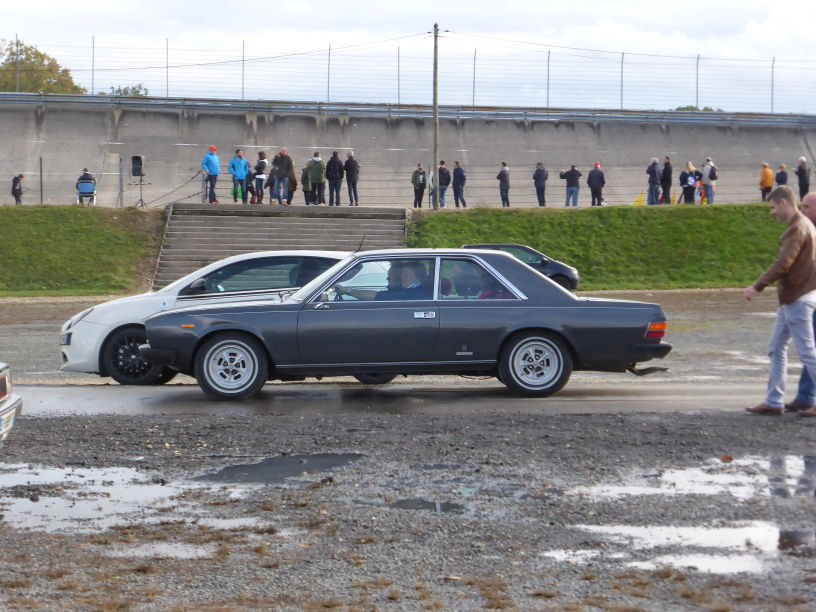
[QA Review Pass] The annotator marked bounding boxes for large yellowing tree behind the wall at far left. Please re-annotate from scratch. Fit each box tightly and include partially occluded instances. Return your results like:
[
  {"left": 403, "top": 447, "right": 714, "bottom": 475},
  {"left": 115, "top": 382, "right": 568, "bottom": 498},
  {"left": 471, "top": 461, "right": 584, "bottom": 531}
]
[{"left": 0, "top": 39, "right": 87, "bottom": 93}]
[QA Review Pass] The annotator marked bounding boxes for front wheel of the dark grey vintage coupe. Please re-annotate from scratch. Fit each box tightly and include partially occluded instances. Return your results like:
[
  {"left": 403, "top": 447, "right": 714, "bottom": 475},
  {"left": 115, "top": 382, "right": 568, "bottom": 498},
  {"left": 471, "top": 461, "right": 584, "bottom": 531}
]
[{"left": 195, "top": 332, "right": 269, "bottom": 400}]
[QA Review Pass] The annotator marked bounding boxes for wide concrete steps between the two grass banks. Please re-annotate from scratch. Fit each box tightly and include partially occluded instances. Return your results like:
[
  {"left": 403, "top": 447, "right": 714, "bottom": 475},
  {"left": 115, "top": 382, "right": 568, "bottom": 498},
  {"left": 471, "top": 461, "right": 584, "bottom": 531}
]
[{"left": 153, "top": 203, "right": 406, "bottom": 289}]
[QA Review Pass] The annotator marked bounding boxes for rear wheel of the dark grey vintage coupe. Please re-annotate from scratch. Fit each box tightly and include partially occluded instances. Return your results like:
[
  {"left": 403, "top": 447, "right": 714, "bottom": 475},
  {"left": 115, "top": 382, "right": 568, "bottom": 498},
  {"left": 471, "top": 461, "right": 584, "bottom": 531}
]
[{"left": 499, "top": 332, "right": 572, "bottom": 397}]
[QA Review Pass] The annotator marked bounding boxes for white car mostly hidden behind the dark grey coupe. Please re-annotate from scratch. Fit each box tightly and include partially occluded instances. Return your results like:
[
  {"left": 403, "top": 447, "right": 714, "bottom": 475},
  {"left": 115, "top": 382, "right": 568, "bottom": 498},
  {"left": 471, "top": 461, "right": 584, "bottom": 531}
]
[{"left": 60, "top": 251, "right": 348, "bottom": 385}]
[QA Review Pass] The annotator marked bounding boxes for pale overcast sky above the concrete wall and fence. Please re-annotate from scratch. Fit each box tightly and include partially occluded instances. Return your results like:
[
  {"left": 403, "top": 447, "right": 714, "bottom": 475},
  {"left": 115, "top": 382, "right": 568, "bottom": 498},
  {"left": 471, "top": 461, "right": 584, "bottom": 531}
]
[{"left": 6, "top": 0, "right": 816, "bottom": 112}]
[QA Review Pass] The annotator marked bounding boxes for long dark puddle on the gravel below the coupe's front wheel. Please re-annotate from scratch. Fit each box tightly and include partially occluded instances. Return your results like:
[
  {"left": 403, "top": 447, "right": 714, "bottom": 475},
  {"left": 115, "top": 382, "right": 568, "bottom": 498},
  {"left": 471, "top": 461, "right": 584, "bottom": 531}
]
[{"left": 194, "top": 453, "right": 363, "bottom": 484}]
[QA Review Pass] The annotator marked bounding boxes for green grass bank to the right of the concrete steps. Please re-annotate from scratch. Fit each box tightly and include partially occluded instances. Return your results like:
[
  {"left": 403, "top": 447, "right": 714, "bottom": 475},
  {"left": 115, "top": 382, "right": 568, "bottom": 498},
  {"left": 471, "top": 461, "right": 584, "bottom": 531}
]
[{"left": 408, "top": 204, "right": 784, "bottom": 289}]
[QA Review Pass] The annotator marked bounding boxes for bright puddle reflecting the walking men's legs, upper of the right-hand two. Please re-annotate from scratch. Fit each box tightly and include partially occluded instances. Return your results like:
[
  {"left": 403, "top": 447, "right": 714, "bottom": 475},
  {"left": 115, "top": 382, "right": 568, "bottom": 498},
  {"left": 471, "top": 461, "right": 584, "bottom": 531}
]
[{"left": 567, "top": 455, "right": 816, "bottom": 500}]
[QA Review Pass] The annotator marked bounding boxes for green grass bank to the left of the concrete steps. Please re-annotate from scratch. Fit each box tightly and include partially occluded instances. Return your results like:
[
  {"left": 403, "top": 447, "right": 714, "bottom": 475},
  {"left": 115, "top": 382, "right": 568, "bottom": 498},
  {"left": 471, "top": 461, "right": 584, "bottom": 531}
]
[{"left": 0, "top": 206, "right": 163, "bottom": 297}]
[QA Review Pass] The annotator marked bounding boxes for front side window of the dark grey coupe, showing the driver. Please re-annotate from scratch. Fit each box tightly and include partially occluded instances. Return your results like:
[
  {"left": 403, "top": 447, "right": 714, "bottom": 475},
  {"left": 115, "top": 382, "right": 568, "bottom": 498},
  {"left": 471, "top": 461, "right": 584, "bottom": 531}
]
[{"left": 321, "top": 259, "right": 435, "bottom": 302}]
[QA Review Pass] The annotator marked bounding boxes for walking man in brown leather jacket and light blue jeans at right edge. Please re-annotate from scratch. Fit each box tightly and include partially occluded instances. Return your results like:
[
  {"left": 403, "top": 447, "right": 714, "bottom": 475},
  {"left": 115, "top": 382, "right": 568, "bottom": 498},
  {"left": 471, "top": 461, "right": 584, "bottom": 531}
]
[{"left": 744, "top": 186, "right": 816, "bottom": 416}]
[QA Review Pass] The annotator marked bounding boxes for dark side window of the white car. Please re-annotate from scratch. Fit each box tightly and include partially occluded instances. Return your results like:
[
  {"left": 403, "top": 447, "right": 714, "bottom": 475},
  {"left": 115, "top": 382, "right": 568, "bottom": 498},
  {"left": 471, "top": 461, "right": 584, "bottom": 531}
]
[{"left": 191, "top": 257, "right": 302, "bottom": 293}]
